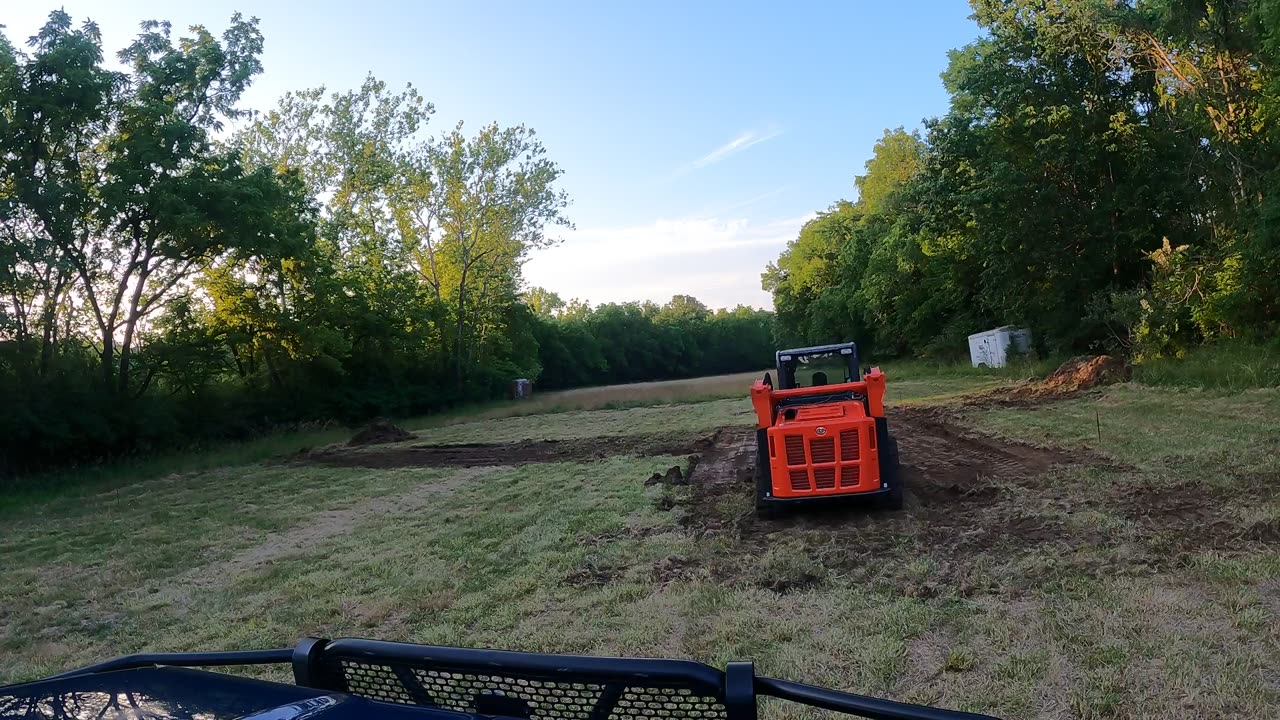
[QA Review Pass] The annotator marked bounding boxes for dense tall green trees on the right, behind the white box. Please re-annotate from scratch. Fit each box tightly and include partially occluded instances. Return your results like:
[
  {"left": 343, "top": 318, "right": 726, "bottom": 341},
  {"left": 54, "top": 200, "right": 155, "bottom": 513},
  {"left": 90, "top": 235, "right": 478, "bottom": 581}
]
[{"left": 763, "top": 0, "right": 1280, "bottom": 357}]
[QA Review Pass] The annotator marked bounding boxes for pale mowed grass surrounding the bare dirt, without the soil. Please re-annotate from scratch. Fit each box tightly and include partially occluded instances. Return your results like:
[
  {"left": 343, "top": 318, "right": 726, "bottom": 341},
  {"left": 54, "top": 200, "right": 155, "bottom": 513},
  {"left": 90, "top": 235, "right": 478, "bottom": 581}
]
[{"left": 0, "top": 377, "right": 1280, "bottom": 717}]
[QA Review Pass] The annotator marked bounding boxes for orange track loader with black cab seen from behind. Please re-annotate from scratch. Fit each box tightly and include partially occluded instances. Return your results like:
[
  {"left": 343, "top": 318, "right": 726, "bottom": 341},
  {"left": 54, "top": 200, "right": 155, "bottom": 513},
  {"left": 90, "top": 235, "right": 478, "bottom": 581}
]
[{"left": 751, "top": 342, "right": 902, "bottom": 515}]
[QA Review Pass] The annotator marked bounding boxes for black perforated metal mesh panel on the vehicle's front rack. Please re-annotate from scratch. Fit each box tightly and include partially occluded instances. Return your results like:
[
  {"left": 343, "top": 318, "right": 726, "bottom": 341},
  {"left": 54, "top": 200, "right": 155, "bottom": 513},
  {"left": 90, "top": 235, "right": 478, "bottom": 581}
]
[{"left": 326, "top": 659, "right": 727, "bottom": 720}]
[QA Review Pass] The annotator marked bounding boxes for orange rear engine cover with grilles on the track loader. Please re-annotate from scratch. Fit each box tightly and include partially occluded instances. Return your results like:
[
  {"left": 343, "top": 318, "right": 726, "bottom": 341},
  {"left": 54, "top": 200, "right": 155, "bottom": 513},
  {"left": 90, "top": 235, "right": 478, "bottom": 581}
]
[{"left": 768, "top": 401, "right": 881, "bottom": 498}]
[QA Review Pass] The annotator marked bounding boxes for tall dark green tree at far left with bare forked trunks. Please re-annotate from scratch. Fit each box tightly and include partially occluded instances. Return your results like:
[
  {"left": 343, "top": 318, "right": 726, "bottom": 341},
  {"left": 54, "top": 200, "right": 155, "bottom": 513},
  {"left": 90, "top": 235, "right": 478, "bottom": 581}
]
[{"left": 0, "top": 12, "right": 306, "bottom": 393}]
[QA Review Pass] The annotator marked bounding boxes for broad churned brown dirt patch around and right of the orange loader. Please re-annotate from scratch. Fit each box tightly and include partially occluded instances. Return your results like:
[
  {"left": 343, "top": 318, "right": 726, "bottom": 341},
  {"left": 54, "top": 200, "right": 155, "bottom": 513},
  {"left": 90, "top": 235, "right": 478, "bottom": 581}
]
[{"left": 682, "top": 407, "right": 1280, "bottom": 597}]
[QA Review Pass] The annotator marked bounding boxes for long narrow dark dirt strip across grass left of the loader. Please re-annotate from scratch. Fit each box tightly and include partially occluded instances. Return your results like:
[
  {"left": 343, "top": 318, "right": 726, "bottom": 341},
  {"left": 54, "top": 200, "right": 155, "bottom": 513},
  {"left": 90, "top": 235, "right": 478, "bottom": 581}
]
[{"left": 298, "top": 430, "right": 719, "bottom": 468}]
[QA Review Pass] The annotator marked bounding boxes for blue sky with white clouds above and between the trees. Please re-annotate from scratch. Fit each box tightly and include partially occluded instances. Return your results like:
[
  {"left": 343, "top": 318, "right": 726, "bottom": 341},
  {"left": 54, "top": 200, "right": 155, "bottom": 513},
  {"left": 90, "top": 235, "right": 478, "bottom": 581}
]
[{"left": 0, "top": 0, "right": 978, "bottom": 307}]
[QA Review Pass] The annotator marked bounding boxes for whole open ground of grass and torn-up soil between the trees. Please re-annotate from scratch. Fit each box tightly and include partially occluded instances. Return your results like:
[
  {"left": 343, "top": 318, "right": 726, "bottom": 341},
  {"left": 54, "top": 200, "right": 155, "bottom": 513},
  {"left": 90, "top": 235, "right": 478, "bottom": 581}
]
[{"left": 0, "top": 368, "right": 1280, "bottom": 717}]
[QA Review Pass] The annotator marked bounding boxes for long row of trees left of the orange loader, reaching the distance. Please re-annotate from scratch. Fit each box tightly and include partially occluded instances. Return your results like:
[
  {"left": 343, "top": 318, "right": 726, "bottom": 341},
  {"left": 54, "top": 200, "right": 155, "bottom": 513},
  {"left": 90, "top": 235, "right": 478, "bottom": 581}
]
[{"left": 0, "top": 12, "right": 771, "bottom": 473}]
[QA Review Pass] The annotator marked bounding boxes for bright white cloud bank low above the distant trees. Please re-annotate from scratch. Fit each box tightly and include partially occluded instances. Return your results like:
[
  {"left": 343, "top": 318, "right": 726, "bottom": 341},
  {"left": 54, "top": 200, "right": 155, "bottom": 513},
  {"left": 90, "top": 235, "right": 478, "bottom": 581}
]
[{"left": 525, "top": 208, "right": 813, "bottom": 307}]
